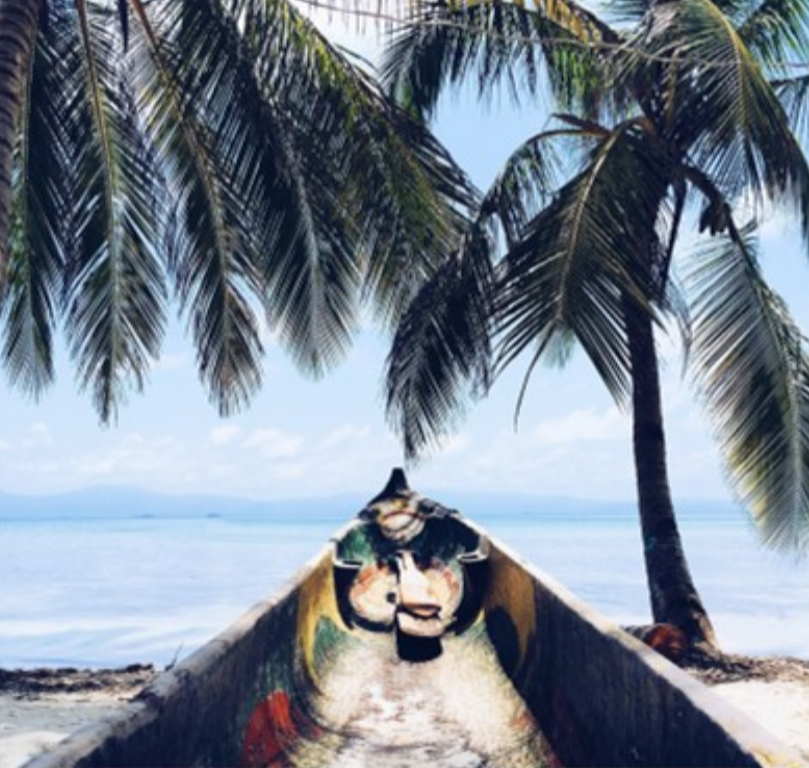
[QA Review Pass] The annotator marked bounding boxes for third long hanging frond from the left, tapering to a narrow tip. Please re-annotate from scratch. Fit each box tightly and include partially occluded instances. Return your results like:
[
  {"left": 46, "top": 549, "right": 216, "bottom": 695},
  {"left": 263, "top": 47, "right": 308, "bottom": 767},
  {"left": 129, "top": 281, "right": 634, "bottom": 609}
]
[{"left": 133, "top": 2, "right": 278, "bottom": 414}]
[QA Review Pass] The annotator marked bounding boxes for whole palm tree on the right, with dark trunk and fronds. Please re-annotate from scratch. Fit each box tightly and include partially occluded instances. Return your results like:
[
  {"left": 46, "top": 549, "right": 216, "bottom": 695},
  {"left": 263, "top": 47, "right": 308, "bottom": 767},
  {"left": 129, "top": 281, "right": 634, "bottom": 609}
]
[{"left": 385, "top": 0, "right": 809, "bottom": 652}]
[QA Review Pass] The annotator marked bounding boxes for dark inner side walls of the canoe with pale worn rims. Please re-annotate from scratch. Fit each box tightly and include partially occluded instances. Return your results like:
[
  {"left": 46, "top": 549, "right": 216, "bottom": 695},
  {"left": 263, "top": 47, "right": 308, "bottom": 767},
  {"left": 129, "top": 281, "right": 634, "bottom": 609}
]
[{"left": 29, "top": 523, "right": 802, "bottom": 768}]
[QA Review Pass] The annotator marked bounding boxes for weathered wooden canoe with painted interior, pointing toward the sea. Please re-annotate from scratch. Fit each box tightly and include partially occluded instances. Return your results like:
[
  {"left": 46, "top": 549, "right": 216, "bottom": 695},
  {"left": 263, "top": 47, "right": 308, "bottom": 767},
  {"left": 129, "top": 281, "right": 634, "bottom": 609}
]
[{"left": 23, "top": 470, "right": 802, "bottom": 768}]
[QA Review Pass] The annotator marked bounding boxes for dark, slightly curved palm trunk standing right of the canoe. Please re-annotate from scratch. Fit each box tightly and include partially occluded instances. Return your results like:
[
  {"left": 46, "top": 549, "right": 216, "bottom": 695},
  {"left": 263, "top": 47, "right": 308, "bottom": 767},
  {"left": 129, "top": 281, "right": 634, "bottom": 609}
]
[{"left": 627, "top": 302, "right": 717, "bottom": 649}]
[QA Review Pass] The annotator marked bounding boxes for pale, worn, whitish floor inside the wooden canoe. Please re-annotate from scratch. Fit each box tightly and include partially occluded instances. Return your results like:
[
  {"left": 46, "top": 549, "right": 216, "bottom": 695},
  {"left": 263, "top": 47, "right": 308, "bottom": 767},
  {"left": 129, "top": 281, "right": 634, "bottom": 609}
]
[{"left": 240, "top": 637, "right": 555, "bottom": 768}]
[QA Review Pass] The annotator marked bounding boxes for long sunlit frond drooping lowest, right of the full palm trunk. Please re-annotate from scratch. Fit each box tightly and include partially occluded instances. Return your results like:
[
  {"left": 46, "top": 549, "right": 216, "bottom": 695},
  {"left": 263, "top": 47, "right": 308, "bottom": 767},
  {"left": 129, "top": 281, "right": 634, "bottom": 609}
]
[{"left": 689, "top": 228, "right": 809, "bottom": 552}]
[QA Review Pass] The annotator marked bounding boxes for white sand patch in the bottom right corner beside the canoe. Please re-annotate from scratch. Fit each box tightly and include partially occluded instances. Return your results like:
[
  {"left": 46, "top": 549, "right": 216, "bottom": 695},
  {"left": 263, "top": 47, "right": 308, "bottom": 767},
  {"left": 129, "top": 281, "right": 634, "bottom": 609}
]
[{"left": 711, "top": 680, "right": 809, "bottom": 762}]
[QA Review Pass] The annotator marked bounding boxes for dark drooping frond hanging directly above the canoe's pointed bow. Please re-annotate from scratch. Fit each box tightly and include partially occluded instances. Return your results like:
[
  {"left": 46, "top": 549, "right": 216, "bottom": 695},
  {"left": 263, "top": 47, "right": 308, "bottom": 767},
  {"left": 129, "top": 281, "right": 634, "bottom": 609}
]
[{"left": 385, "top": 221, "right": 494, "bottom": 460}]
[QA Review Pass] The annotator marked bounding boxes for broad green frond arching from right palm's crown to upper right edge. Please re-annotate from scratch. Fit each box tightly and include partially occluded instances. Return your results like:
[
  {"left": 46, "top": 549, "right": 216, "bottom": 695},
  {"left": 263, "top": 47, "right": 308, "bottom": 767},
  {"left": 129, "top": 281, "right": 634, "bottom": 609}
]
[{"left": 627, "top": 0, "right": 809, "bottom": 228}]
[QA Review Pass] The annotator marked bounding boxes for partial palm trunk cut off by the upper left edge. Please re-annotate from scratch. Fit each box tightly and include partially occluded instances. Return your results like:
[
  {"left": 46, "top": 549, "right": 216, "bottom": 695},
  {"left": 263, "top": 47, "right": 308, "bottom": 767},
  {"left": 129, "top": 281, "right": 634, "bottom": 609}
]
[{"left": 0, "top": 0, "right": 42, "bottom": 299}]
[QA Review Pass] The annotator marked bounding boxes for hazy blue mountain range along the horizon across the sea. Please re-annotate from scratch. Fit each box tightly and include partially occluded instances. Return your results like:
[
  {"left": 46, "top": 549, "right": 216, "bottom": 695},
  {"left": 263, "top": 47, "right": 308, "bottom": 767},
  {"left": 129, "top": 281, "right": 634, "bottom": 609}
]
[{"left": 0, "top": 486, "right": 738, "bottom": 522}]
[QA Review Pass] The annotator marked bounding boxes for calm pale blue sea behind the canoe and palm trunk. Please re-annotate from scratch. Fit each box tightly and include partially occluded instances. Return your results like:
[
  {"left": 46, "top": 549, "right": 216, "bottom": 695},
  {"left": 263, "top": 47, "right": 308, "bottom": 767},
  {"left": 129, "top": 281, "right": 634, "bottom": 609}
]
[{"left": 0, "top": 500, "right": 809, "bottom": 667}]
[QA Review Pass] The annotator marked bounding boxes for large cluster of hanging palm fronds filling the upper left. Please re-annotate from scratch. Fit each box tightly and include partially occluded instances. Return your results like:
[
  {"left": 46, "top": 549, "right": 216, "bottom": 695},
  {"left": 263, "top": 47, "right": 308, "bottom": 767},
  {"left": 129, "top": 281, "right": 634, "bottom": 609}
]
[{"left": 0, "top": 0, "right": 472, "bottom": 422}]
